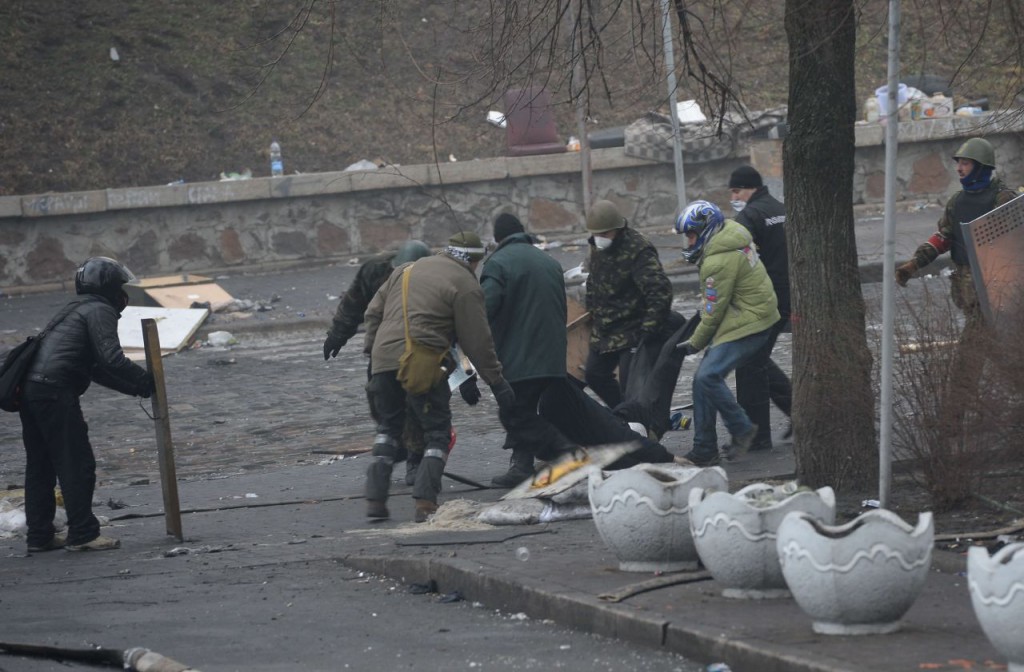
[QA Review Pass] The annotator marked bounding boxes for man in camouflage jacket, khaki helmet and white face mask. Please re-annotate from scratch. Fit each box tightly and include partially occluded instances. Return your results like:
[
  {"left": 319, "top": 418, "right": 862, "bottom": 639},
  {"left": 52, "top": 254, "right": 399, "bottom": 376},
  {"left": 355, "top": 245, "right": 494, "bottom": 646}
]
[{"left": 586, "top": 201, "right": 672, "bottom": 409}]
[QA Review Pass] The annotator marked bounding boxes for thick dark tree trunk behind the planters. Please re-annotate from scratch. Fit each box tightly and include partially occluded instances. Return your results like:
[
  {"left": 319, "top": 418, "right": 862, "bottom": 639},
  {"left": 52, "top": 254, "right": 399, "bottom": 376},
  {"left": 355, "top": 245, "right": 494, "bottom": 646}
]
[{"left": 783, "top": 0, "right": 878, "bottom": 490}]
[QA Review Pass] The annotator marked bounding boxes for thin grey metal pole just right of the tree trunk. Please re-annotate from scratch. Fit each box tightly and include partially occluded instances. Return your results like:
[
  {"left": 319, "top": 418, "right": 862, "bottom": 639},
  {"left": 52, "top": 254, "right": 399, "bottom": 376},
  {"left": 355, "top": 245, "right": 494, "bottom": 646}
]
[{"left": 879, "top": 0, "right": 900, "bottom": 508}]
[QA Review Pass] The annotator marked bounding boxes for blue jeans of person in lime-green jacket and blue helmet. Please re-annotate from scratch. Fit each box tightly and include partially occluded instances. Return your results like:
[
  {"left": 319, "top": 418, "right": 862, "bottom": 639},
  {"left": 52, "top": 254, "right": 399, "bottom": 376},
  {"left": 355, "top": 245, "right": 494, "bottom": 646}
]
[{"left": 693, "top": 329, "right": 771, "bottom": 456}]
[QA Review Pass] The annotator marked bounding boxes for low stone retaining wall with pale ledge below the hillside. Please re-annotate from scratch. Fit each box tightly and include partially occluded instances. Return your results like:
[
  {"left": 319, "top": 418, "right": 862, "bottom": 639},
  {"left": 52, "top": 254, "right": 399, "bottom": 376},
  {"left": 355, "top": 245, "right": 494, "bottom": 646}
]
[{"left": 0, "top": 115, "right": 1024, "bottom": 288}]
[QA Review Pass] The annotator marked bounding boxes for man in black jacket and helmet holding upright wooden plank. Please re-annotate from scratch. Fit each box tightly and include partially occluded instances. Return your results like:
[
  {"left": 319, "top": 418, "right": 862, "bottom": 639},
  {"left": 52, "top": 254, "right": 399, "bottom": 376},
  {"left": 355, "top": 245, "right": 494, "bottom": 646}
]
[{"left": 19, "top": 257, "right": 153, "bottom": 553}]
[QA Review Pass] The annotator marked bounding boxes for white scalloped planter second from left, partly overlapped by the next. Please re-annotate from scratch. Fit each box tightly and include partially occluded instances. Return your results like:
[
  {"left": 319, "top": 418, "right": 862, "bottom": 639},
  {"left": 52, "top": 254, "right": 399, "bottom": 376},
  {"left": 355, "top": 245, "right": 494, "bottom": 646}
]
[{"left": 689, "top": 481, "right": 836, "bottom": 599}]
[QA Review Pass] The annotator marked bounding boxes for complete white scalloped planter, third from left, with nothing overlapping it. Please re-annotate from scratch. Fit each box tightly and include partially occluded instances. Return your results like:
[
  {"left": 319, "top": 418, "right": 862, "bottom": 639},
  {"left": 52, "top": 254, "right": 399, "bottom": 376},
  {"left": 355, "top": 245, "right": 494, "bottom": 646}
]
[{"left": 776, "top": 509, "right": 935, "bottom": 635}]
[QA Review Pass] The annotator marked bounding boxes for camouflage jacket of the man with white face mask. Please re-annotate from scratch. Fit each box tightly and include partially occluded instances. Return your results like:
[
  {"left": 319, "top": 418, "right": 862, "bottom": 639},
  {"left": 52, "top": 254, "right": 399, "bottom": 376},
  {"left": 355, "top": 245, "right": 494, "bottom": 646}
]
[{"left": 587, "top": 226, "right": 672, "bottom": 352}]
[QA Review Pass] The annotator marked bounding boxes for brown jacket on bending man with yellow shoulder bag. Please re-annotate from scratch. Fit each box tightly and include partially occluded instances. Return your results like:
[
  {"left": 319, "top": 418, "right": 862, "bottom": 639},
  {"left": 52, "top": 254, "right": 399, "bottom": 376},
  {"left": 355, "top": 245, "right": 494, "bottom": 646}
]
[{"left": 364, "top": 254, "right": 502, "bottom": 385}]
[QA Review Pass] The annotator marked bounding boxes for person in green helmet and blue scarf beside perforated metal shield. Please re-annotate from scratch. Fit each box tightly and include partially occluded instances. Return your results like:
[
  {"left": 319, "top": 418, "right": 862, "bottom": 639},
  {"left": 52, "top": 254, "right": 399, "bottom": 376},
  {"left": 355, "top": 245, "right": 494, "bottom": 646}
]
[{"left": 896, "top": 137, "right": 1017, "bottom": 426}]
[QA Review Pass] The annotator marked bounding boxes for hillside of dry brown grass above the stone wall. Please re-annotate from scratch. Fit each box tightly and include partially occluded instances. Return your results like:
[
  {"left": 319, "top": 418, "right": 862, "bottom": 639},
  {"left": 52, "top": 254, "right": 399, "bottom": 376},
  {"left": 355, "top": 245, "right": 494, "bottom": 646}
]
[{"left": 0, "top": 0, "right": 1021, "bottom": 195}]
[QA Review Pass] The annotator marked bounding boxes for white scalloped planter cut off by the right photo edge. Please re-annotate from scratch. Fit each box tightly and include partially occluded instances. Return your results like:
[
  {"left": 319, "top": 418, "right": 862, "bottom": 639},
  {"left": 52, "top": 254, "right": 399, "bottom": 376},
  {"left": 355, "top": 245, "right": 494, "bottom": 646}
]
[{"left": 967, "top": 542, "right": 1024, "bottom": 672}]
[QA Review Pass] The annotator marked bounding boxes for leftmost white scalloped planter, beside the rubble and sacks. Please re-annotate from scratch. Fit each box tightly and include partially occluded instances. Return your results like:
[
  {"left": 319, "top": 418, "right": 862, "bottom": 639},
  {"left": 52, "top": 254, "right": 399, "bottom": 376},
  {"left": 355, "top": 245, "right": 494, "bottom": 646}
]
[{"left": 588, "top": 464, "right": 729, "bottom": 572}]
